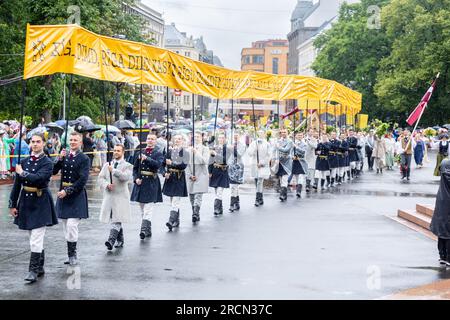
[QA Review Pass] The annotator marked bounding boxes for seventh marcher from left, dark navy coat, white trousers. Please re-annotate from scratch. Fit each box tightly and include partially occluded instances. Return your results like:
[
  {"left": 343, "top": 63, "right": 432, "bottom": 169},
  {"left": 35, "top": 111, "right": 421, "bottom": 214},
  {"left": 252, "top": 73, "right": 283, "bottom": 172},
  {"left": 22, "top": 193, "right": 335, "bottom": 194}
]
[{"left": 208, "top": 133, "right": 233, "bottom": 216}]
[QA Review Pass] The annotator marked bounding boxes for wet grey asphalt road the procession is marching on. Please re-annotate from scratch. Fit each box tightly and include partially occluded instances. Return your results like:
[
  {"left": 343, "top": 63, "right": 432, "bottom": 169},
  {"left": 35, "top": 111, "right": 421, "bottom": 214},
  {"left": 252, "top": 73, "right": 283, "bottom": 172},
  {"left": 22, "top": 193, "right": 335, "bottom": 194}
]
[{"left": 0, "top": 155, "right": 442, "bottom": 300}]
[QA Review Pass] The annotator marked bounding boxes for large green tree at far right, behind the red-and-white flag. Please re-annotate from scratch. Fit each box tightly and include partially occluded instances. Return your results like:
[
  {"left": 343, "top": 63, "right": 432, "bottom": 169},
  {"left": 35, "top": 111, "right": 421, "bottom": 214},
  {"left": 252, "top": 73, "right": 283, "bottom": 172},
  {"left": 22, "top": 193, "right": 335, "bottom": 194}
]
[{"left": 375, "top": 0, "right": 450, "bottom": 126}]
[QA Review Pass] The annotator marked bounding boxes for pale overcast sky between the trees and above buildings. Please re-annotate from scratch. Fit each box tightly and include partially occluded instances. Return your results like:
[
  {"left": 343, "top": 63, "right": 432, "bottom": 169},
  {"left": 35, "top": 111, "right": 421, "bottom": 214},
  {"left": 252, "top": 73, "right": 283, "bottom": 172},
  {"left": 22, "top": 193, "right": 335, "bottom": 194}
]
[{"left": 142, "top": 0, "right": 297, "bottom": 70}]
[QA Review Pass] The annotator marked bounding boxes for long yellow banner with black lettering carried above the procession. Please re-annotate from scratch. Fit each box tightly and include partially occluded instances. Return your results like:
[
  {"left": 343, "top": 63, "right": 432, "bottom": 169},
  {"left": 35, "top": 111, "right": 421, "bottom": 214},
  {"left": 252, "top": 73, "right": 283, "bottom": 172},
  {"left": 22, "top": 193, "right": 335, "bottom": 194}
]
[{"left": 24, "top": 25, "right": 362, "bottom": 112}]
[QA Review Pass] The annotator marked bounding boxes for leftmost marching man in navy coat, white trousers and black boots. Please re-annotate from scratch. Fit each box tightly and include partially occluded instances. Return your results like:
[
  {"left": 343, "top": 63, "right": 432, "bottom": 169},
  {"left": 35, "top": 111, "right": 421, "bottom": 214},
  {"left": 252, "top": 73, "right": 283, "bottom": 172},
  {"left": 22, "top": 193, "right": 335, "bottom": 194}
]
[{"left": 8, "top": 134, "right": 58, "bottom": 283}]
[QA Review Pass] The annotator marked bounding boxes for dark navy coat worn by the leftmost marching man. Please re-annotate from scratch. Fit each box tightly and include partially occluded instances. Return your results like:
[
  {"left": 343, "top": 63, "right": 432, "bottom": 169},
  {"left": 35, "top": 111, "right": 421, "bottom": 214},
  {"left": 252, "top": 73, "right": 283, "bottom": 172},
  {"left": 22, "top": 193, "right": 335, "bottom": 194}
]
[{"left": 9, "top": 154, "right": 58, "bottom": 230}]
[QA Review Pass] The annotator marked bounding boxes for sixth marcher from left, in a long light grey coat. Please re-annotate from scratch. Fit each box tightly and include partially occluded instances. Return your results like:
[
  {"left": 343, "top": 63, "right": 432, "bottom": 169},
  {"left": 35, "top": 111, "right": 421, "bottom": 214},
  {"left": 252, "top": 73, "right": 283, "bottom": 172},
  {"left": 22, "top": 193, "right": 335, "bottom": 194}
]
[{"left": 186, "top": 132, "right": 209, "bottom": 223}]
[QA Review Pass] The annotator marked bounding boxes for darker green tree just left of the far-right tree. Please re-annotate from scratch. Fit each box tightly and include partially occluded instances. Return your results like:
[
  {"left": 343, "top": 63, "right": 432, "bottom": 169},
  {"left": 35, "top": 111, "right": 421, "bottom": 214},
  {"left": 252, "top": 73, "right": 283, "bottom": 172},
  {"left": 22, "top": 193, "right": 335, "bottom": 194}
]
[{"left": 312, "top": 0, "right": 390, "bottom": 117}]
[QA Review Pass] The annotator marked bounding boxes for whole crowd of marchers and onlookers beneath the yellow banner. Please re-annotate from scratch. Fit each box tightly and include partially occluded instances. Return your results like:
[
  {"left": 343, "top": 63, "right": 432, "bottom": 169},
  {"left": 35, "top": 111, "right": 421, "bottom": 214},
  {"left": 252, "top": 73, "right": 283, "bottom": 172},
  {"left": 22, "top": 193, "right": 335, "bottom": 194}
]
[{"left": 0, "top": 115, "right": 449, "bottom": 283}]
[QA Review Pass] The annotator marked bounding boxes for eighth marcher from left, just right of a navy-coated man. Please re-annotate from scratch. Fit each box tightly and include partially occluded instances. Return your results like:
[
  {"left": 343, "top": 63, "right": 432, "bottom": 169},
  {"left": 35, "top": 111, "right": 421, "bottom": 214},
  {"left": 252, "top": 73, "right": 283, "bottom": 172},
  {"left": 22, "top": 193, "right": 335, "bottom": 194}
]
[{"left": 228, "top": 132, "right": 246, "bottom": 212}]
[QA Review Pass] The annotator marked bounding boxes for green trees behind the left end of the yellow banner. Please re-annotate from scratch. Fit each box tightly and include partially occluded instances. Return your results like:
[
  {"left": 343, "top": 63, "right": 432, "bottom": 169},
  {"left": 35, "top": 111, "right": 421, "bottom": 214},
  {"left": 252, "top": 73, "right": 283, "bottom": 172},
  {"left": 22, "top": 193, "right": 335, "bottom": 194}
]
[{"left": 0, "top": 0, "right": 147, "bottom": 125}]
